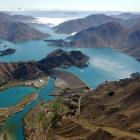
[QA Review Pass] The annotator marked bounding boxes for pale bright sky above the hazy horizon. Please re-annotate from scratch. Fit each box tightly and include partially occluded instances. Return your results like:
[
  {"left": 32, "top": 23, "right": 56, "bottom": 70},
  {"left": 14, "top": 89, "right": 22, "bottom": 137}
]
[{"left": 0, "top": 0, "right": 140, "bottom": 12}]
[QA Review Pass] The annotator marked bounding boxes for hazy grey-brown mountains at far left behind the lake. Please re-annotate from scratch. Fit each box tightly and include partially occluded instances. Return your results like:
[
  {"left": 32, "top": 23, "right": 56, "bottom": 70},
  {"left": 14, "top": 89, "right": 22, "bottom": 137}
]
[{"left": 0, "top": 13, "right": 48, "bottom": 42}]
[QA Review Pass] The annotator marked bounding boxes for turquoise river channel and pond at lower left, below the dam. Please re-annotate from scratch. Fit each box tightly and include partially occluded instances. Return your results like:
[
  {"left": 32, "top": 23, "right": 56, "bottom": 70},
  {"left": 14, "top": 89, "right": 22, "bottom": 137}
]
[{"left": 0, "top": 79, "right": 55, "bottom": 140}]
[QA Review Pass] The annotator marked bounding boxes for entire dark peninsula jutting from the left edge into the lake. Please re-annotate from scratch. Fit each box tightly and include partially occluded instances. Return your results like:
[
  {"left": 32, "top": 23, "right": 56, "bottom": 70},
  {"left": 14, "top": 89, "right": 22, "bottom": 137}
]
[{"left": 0, "top": 49, "right": 89, "bottom": 88}]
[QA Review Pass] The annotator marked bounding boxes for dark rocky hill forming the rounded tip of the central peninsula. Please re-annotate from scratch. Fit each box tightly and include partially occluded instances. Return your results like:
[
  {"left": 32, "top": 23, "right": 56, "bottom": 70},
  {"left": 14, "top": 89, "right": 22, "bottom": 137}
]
[{"left": 38, "top": 49, "right": 88, "bottom": 71}]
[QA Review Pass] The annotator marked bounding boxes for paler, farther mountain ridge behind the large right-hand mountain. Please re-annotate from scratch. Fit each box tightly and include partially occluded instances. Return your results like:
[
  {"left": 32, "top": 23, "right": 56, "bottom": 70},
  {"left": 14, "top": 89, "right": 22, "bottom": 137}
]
[{"left": 54, "top": 14, "right": 122, "bottom": 34}]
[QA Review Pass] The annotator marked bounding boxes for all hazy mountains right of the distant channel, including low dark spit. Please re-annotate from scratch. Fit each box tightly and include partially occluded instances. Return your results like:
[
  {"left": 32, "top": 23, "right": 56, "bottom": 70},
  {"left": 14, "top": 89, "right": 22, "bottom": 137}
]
[{"left": 48, "top": 15, "right": 140, "bottom": 60}]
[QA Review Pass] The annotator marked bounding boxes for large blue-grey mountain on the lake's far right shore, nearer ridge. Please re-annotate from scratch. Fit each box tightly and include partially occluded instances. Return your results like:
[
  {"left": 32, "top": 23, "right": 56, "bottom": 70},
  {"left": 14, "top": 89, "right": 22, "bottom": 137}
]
[{"left": 70, "top": 22, "right": 140, "bottom": 60}]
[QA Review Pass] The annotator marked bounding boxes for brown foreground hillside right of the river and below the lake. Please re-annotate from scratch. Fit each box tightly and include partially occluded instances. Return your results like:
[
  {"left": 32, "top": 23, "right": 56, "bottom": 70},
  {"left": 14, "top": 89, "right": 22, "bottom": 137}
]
[{"left": 25, "top": 73, "right": 140, "bottom": 140}]
